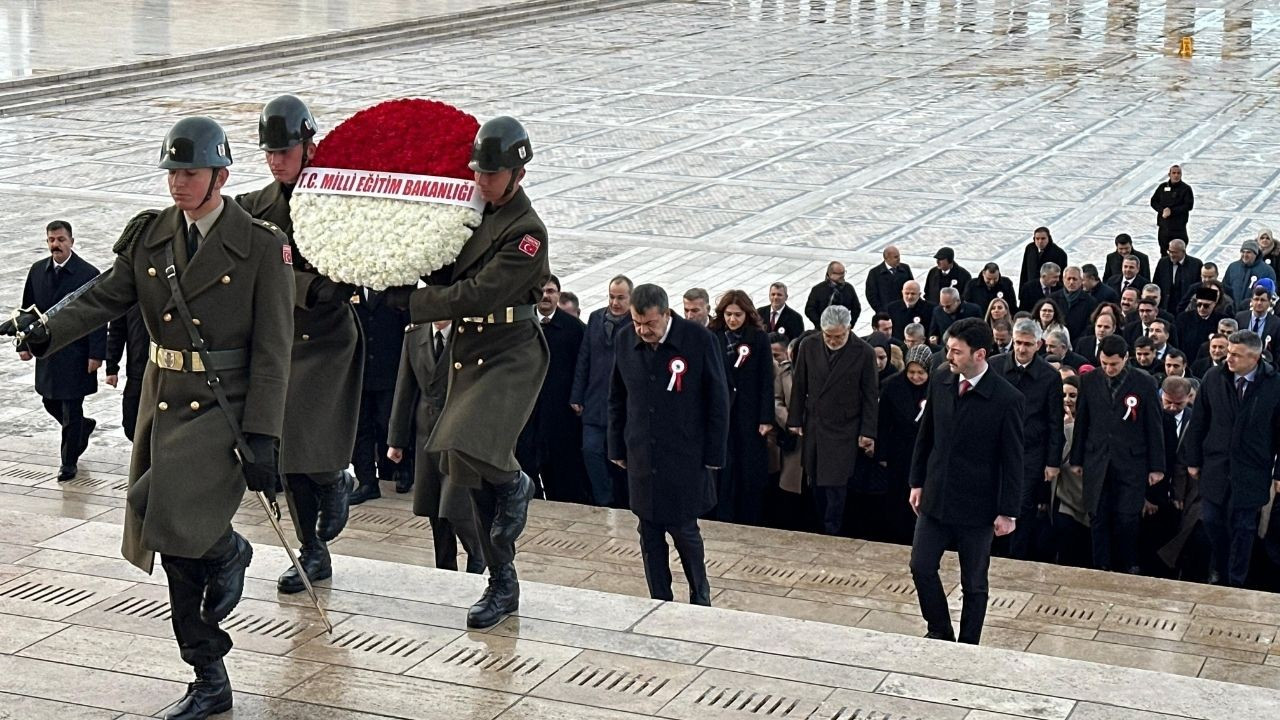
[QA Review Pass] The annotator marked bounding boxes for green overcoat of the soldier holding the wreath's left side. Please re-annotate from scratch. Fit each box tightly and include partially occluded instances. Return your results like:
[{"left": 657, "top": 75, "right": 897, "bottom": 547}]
[{"left": 236, "top": 182, "right": 365, "bottom": 474}]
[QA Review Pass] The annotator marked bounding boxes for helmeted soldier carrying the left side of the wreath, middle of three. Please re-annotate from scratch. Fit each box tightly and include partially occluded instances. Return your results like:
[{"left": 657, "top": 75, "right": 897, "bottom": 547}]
[{"left": 236, "top": 95, "right": 365, "bottom": 593}]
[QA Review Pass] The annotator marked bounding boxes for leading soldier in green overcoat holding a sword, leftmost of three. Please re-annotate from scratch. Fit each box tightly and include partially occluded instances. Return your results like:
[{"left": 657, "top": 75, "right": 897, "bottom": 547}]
[{"left": 0, "top": 117, "right": 293, "bottom": 720}]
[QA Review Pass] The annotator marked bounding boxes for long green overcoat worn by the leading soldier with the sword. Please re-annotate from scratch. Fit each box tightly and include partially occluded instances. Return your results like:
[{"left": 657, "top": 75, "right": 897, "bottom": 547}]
[{"left": 38, "top": 197, "right": 293, "bottom": 573}]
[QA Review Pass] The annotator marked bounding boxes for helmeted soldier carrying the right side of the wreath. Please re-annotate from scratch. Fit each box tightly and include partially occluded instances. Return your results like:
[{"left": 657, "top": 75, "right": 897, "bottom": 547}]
[{"left": 385, "top": 117, "right": 550, "bottom": 628}]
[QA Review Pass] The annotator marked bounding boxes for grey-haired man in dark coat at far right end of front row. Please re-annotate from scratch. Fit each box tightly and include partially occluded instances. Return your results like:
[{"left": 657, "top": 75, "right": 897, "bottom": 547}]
[{"left": 1184, "top": 331, "right": 1280, "bottom": 587}]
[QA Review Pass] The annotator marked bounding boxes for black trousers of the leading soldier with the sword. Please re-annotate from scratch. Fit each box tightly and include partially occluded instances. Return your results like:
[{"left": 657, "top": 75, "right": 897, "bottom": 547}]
[{"left": 160, "top": 527, "right": 236, "bottom": 667}]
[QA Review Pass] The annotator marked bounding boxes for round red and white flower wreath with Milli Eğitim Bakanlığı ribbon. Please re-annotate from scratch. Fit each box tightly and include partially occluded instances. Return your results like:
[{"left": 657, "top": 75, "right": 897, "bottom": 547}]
[{"left": 289, "top": 99, "right": 484, "bottom": 290}]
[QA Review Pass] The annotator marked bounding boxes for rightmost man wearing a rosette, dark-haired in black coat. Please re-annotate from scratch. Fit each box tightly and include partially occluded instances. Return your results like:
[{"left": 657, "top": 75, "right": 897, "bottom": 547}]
[{"left": 1070, "top": 334, "right": 1165, "bottom": 573}]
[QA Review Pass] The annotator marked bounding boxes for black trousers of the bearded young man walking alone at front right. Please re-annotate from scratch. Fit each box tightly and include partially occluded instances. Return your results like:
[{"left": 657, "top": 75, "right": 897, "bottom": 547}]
[{"left": 911, "top": 514, "right": 995, "bottom": 644}]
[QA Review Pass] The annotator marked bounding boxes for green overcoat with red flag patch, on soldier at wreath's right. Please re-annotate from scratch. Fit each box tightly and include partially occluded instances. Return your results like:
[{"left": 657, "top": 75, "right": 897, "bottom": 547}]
[{"left": 410, "top": 190, "right": 550, "bottom": 487}]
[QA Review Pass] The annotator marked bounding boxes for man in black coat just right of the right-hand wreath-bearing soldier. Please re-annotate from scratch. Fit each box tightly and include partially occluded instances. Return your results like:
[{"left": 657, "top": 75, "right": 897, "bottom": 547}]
[{"left": 516, "top": 275, "right": 591, "bottom": 503}]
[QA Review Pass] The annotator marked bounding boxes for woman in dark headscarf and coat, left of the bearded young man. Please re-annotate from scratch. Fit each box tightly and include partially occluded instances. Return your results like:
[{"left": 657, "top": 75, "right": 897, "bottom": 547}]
[{"left": 876, "top": 346, "right": 931, "bottom": 544}]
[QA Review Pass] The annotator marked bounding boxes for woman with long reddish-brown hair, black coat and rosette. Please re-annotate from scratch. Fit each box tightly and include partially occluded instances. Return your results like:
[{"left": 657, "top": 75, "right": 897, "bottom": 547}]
[{"left": 710, "top": 290, "right": 773, "bottom": 525}]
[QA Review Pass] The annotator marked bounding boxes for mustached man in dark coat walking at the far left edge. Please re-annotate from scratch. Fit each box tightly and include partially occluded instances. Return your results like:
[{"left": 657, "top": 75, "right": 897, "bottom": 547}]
[{"left": 18, "top": 220, "right": 106, "bottom": 480}]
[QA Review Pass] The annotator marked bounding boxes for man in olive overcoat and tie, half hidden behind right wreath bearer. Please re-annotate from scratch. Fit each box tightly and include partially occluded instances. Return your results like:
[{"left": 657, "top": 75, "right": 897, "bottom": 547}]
[{"left": 387, "top": 320, "right": 484, "bottom": 574}]
